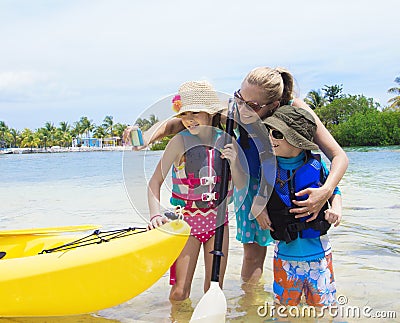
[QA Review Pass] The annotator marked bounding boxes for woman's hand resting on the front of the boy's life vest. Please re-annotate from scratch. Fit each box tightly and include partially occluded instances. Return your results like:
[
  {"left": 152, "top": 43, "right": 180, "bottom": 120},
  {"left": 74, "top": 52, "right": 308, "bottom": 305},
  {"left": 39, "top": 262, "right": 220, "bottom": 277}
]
[{"left": 289, "top": 186, "right": 332, "bottom": 222}]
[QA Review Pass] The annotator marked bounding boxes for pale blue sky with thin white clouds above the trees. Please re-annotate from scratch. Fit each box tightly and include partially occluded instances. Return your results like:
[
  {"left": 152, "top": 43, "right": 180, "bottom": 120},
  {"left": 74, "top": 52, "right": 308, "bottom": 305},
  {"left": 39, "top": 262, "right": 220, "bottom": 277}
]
[{"left": 0, "top": 0, "right": 400, "bottom": 130}]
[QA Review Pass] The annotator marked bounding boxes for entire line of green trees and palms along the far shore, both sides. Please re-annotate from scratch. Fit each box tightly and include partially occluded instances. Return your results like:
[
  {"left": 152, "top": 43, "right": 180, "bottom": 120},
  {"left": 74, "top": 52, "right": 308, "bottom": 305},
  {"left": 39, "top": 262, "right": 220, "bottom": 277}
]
[{"left": 0, "top": 77, "right": 400, "bottom": 149}]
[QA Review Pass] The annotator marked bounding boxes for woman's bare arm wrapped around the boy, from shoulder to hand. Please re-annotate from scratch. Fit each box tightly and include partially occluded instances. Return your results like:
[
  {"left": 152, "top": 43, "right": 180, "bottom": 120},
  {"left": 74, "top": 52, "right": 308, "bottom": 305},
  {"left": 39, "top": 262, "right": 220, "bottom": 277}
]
[{"left": 290, "top": 99, "right": 349, "bottom": 221}]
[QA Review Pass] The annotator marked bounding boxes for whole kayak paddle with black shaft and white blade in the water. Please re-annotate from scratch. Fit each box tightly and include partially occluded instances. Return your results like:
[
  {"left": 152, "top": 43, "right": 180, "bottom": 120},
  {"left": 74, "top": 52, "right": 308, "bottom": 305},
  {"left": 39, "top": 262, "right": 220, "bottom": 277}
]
[{"left": 190, "top": 98, "right": 236, "bottom": 323}]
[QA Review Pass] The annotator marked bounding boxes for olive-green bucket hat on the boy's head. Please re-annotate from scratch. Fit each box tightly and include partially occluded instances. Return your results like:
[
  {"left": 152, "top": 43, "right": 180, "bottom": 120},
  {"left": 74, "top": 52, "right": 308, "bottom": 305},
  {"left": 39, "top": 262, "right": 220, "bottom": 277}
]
[{"left": 263, "top": 105, "right": 319, "bottom": 150}]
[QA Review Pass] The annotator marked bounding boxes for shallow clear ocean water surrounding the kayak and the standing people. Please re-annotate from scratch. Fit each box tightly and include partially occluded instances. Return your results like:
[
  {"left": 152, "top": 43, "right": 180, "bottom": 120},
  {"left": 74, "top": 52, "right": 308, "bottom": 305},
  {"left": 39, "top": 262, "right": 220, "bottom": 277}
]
[{"left": 0, "top": 146, "right": 400, "bottom": 323}]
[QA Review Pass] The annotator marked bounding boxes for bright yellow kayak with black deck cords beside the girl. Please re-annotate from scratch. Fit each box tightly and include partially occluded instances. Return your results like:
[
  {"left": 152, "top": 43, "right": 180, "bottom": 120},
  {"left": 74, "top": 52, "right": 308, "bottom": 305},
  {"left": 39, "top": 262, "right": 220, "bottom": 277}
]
[{"left": 0, "top": 220, "right": 190, "bottom": 317}]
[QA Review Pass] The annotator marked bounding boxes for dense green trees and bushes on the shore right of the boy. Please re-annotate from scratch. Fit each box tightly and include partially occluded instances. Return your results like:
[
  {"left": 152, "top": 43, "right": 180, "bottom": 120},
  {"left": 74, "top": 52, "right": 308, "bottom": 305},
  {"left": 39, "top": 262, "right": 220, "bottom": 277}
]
[{"left": 304, "top": 77, "right": 400, "bottom": 147}]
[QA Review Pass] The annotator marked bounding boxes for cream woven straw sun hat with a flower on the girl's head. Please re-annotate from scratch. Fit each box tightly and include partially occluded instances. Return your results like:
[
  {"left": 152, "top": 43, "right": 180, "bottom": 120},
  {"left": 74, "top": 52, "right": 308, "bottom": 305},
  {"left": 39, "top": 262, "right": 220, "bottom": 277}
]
[{"left": 172, "top": 81, "right": 225, "bottom": 116}]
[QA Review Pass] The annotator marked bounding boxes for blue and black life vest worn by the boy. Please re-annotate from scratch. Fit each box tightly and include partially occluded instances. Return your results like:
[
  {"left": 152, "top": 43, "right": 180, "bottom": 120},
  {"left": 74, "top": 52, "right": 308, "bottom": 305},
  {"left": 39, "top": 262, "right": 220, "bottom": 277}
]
[{"left": 267, "top": 154, "right": 330, "bottom": 243}]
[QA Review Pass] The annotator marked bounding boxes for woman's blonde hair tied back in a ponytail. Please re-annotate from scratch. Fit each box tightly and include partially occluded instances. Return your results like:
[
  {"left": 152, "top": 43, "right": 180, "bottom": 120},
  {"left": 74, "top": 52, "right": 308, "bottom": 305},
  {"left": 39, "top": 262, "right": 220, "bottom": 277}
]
[{"left": 244, "top": 67, "right": 294, "bottom": 106}]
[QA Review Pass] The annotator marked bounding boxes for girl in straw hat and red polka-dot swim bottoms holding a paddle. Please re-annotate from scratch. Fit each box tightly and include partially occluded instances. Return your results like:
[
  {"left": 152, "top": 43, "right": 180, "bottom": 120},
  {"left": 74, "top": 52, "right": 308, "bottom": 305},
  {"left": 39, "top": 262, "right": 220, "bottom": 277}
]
[{"left": 148, "top": 81, "right": 245, "bottom": 300}]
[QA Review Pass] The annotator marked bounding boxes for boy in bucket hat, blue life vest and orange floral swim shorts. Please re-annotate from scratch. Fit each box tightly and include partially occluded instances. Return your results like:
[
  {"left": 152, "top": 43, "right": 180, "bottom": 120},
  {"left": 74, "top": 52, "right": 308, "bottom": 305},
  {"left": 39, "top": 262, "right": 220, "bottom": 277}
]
[{"left": 264, "top": 105, "right": 342, "bottom": 306}]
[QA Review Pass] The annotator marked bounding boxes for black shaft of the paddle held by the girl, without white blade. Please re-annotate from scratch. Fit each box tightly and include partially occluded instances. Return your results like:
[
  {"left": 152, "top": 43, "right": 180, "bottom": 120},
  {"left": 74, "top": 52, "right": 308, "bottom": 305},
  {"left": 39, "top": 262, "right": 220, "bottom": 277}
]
[{"left": 211, "top": 99, "right": 235, "bottom": 282}]
